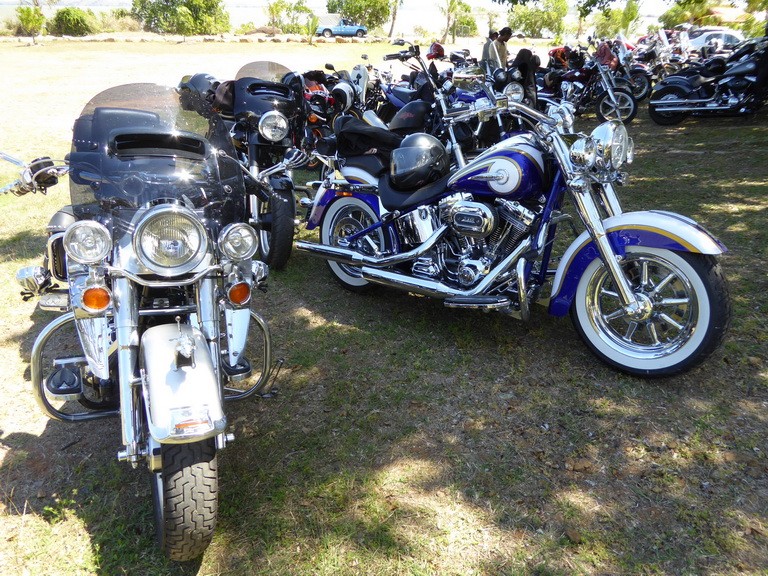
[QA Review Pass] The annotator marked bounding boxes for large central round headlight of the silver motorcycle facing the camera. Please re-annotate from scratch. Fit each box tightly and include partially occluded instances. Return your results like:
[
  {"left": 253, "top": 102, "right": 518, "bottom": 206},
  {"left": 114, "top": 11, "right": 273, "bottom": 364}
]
[{"left": 133, "top": 205, "right": 208, "bottom": 276}]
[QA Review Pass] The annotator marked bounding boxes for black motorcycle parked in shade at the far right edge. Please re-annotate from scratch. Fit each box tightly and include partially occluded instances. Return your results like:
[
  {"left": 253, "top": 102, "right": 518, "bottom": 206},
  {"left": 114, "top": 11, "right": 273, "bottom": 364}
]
[{"left": 648, "top": 37, "right": 768, "bottom": 126}]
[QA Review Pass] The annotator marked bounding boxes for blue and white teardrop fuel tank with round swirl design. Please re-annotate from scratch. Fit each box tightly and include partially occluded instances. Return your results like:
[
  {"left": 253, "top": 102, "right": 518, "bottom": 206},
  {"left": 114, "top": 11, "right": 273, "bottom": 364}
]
[{"left": 448, "top": 134, "right": 548, "bottom": 200}]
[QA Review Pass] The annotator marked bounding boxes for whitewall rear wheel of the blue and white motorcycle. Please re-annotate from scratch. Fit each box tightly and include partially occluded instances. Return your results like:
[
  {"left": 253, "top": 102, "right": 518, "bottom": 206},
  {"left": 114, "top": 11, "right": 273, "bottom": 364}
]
[{"left": 320, "top": 198, "right": 386, "bottom": 293}]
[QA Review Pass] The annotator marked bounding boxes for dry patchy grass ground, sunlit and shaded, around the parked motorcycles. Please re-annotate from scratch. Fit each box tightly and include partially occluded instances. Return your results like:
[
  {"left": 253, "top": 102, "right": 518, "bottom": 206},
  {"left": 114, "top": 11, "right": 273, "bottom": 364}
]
[{"left": 0, "top": 38, "right": 768, "bottom": 576}]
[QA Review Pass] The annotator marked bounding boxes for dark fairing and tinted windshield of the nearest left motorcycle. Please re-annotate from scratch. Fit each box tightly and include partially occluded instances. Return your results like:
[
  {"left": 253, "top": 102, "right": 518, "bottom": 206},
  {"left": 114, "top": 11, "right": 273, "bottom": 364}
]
[{"left": 69, "top": 84, "right": 245, "bottom": 221}]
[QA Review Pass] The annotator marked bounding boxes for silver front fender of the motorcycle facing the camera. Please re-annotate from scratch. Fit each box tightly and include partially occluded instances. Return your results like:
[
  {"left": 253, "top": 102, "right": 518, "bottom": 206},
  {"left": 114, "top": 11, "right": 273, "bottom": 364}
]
[{"left": 139, "top": 324, "right": 227, "bottom": 444}]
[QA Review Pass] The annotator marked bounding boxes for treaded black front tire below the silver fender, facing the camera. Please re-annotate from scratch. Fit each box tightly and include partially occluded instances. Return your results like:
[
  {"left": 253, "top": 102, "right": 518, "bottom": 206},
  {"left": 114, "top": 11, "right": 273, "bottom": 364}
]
[{"left": 152, "top": 438, "right": 219, "bottom": 562}]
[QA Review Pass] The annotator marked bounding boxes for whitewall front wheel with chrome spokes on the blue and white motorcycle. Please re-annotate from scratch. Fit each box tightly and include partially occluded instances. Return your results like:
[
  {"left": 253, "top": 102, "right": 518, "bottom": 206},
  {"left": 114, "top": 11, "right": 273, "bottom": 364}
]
[{"left": 571, "top": 247, "right": 731, "bottom": 377}]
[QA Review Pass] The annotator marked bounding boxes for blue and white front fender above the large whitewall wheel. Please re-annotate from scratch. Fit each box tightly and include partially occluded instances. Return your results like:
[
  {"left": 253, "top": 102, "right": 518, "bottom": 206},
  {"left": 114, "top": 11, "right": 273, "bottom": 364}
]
[{"left": 549, "top": 210, "right": 727, "bottom": 316}]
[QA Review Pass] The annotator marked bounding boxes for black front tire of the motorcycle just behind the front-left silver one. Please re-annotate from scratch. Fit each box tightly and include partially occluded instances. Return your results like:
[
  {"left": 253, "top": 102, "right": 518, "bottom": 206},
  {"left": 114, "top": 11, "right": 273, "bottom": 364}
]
[{"left": 256, "top": 190, "right": 295, "bottom": 270}]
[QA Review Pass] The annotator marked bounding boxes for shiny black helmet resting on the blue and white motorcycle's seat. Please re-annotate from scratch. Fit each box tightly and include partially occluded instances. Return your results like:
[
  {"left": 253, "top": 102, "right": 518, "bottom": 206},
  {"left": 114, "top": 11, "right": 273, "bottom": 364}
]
[{"left": 389, "top": 134, "right": 450, "bottom": 190}]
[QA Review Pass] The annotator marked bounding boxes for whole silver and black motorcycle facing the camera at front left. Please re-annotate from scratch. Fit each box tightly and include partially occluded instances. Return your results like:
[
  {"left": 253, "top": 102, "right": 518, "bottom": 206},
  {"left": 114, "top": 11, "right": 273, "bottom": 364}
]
[{"left": 3, "top": 84, "right": 293, "bottom": 561}]
